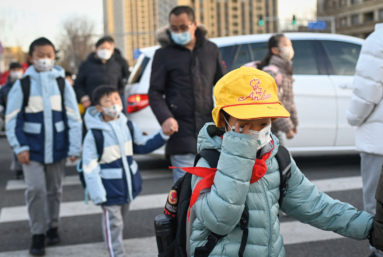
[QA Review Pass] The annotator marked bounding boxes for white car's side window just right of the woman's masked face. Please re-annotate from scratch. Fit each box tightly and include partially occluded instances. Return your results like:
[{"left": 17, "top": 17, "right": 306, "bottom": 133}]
[{"left": 292, "top": 40, "right": 319, "bottom": 75}]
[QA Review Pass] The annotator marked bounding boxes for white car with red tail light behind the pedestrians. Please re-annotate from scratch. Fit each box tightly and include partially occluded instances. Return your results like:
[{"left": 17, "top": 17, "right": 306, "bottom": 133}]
[{"left": 125, "top": 33, "right": 364, "bottom": 156}]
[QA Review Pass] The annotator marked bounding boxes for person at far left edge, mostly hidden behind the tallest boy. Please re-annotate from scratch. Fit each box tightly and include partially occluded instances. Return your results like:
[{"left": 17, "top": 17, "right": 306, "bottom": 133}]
[{"left": 0, "top": 62, "right": 24, "bottom": 179}]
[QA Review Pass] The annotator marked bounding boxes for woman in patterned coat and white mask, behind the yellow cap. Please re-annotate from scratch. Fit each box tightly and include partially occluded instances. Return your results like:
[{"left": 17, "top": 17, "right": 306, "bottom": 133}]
[{"left": 257, "top": 34, "right": 298, "bottom": 145}]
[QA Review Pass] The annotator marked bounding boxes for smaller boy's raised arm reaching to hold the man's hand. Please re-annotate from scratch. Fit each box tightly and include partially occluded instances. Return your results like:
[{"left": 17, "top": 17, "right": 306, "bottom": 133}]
[{"left": 132, "top": 122, "right": 169, "bottom": 154}]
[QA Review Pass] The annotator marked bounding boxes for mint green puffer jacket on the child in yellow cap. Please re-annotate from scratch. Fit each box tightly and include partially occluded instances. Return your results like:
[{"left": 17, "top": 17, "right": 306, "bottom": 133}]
[{"left": 190, "top": 123, "right": 373, "bottom": 257}]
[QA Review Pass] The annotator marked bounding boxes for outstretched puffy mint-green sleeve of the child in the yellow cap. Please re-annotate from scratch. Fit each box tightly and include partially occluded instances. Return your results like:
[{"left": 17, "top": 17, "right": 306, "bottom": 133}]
[{"left": 282, "top": 159, "right": 373, "bottom": 240}]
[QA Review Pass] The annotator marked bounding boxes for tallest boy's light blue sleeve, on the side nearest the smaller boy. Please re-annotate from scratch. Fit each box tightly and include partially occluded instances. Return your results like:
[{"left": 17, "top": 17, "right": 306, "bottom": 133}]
[{"left": 64, "top": 80, "right": 82, "bottom": 157}]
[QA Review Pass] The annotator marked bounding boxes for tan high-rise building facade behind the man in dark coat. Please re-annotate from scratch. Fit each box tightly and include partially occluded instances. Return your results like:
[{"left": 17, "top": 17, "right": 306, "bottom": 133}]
[{"left": 103, "top": 0, "right": 278, "bottom": 63}]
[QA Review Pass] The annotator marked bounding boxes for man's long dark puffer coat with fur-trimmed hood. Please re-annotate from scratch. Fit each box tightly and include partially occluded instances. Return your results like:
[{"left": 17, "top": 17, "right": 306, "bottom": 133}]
[{"left": 149, "top": 27, "right": 225, "bottom": 155}]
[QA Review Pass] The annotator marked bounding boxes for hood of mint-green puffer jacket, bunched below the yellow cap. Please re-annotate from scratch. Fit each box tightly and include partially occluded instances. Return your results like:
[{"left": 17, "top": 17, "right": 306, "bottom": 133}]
[{"left": 197, "top": 122, "right": 279, "bottom": 159}]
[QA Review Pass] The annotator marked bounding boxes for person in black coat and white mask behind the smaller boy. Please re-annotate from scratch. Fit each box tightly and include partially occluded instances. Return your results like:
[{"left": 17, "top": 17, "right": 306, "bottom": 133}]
[{"left": 74, "top": 36, "right": 129, "bottom": 108}]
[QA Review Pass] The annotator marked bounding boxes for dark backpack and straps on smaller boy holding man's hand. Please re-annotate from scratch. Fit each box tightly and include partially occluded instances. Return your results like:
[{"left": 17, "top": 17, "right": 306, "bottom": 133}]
[{"left": 77, "top": 120, "right": 141, "bottom": 203}]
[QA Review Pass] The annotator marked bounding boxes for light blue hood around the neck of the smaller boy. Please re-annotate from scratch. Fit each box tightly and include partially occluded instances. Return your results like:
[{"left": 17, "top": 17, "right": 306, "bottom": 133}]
[{"left": 84, "top": 106, "right": 128, "bottom": 130}]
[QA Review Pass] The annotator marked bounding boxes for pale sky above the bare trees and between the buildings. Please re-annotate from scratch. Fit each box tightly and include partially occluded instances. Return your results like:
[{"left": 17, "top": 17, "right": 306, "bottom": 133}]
[{"left": 0, "top": 0, "right": 316, "bottom": 51}]
